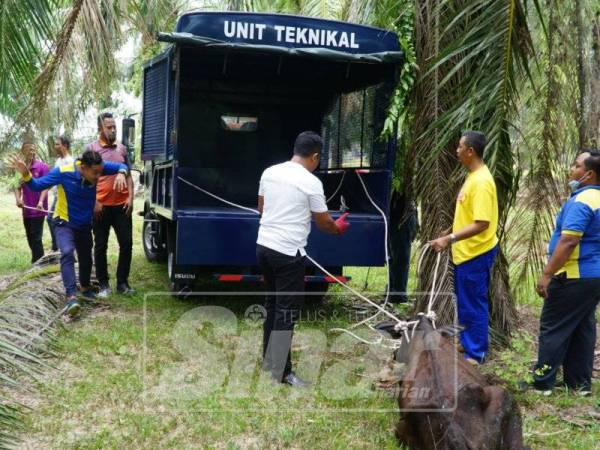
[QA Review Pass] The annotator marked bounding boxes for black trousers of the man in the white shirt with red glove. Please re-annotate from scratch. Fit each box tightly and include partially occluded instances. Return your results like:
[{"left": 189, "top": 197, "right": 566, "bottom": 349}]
[{"left": 256, "top": 245, "right": 304, "bottom": 381}]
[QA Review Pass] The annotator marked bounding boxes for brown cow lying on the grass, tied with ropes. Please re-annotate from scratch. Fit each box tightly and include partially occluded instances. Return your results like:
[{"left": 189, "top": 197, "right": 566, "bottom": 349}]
[{"left": 396, "top": 317, "right": 523, "bottom": 450}]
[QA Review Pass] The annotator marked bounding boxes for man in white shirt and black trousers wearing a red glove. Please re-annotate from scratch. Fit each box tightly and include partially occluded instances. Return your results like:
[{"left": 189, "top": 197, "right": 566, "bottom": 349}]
[{"left": 256, "top": 131, "right": 350, "bottom": 387}]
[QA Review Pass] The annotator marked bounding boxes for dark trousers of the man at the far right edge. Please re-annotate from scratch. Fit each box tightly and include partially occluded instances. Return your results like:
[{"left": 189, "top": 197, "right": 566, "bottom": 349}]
[{"left": 533, "top": 277, "right": 600, "bottom": 390}]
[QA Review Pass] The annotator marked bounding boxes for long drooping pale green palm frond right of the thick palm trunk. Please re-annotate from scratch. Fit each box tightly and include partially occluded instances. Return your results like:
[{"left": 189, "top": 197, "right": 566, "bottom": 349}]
[{"left": 507, "top": 0, "right": 578, "bottom": 302}]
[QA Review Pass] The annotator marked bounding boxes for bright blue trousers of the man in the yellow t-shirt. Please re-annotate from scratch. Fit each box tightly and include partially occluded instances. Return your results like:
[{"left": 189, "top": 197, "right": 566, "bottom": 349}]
[{"left": 454, "top": 246, "right": 498, "bottom": 363}]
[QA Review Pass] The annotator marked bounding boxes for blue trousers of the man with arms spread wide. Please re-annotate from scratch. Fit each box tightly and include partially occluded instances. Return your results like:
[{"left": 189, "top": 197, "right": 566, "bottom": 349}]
[{"left": 54, "top": 220, "right": 93, "bottom": 297}]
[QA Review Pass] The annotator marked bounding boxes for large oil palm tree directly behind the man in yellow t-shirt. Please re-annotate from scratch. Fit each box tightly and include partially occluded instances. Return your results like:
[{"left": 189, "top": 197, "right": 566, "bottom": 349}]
[{"left": 409, "top": 0, "right": 534, "bottom": 337}]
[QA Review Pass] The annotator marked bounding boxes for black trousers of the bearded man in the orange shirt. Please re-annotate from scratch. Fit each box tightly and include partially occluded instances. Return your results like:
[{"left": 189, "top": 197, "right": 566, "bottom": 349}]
[{"left": 94, "top": 205, "right": 133, "bottom": 286}]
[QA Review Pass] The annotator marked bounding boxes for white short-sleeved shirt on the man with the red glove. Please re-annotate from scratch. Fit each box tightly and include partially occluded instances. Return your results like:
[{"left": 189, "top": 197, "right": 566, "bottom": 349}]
[{"left": 256, "top": 161, "right": 327, "bottom": 256}]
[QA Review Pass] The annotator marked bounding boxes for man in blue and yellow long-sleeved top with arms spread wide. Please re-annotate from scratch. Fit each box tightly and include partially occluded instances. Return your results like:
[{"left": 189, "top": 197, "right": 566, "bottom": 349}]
[{"left": 9, "top": 150, "right": 128, "bottom": 316}]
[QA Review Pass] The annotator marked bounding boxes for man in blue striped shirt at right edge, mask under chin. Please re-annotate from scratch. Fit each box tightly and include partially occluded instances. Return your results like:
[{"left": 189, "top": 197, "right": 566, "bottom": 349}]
[{"left": 533, "top": 150, "right": 600, "bottom": 395}]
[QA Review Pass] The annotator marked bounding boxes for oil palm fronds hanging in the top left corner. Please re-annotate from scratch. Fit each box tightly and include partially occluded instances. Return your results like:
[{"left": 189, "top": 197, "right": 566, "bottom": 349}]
[{"left": 0, "top": 0, "right": 188, "bottom": 146}]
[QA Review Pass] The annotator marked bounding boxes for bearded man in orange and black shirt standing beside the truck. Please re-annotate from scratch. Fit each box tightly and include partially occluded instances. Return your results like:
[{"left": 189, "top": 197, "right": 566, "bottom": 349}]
[{"left": 86, "top": 112, "right": 135, "bottom": 298}]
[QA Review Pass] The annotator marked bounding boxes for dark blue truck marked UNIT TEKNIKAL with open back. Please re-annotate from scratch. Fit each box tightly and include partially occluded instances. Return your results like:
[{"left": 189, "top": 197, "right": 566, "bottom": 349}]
[{"left": 141, "top": 12, "right": 403, "bottom": 293}]
